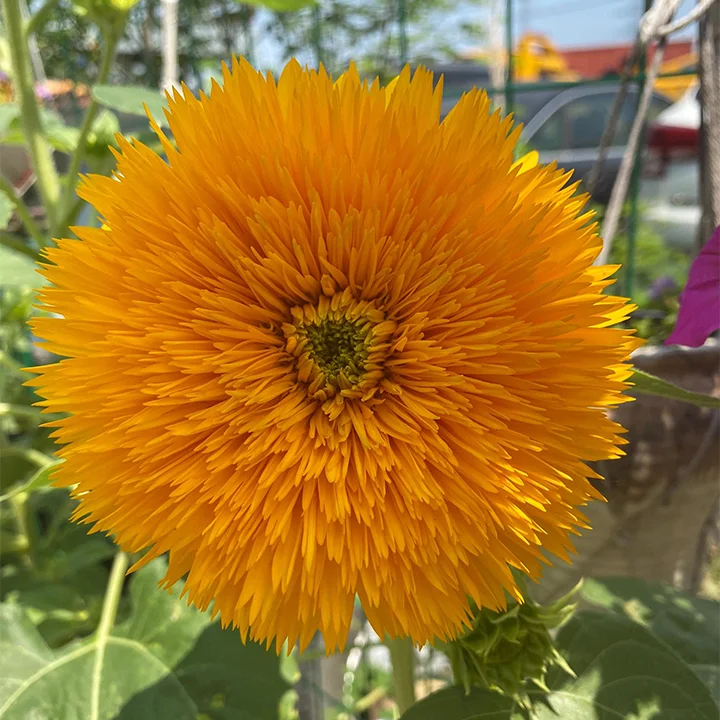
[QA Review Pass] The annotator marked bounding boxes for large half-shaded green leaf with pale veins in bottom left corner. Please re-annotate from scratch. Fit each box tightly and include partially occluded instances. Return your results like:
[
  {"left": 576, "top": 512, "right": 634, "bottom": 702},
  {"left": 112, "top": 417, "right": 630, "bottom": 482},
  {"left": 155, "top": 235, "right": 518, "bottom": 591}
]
[{"left": 0, "top": 560, "right": 288, "bottom": 720}]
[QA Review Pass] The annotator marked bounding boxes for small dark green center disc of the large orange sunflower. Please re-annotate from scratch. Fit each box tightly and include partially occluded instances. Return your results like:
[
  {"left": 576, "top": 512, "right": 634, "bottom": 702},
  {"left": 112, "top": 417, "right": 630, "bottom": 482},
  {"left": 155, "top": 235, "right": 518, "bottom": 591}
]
[{"left": 303, "top": 318, "right": 368, "bottom": 379}]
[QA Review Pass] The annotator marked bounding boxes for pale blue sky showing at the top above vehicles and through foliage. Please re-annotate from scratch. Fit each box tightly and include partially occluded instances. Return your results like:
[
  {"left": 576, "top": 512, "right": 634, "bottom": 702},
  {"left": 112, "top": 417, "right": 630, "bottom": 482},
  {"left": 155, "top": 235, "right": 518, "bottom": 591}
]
[{"left": 255, "top": 0, "right": 696, "bottom": 68}]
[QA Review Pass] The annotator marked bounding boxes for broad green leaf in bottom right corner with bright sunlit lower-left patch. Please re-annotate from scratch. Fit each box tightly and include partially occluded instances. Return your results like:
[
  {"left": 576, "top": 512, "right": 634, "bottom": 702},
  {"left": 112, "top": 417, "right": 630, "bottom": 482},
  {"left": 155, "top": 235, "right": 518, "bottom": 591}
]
[{"left": 544, "top": 611, "right": 718, "bottom": 720}]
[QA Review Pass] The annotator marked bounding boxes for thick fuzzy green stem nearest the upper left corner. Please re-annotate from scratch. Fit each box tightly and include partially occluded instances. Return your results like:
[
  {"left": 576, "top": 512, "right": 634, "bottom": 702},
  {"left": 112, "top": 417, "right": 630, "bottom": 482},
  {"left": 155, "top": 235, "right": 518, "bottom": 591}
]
[{"left": 2, "top": 0, "right": 60, "bottom": 227}]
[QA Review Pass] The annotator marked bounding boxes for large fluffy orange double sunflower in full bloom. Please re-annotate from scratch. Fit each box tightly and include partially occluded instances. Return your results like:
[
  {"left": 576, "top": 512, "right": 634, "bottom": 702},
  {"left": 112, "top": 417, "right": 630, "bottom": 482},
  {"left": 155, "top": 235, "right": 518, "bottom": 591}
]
[{"left": 32, "top": 61, "right": 637, "bottom": 649}]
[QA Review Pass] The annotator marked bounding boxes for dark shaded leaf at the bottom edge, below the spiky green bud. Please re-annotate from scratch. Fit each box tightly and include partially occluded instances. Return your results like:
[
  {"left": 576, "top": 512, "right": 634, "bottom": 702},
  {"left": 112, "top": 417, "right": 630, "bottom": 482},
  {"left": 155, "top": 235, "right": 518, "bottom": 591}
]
[{"left": 402, "top": 685, "right": 516, "bottom": 720}]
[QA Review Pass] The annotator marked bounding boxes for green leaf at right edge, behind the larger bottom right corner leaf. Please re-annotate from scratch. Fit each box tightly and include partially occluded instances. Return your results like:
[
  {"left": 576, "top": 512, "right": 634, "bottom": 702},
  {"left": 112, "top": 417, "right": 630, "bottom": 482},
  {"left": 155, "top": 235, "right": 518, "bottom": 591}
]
[{"left": 580, "top": 577, "right": 720, "bottom": 665}]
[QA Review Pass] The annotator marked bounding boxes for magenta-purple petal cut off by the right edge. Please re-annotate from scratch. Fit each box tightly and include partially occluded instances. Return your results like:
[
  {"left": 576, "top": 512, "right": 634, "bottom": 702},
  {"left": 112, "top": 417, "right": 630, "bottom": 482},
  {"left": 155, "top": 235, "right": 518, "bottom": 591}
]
[{"left": 665, "top": 226, "right": 720, "bottom": 347}]
